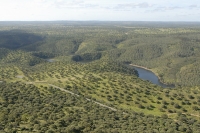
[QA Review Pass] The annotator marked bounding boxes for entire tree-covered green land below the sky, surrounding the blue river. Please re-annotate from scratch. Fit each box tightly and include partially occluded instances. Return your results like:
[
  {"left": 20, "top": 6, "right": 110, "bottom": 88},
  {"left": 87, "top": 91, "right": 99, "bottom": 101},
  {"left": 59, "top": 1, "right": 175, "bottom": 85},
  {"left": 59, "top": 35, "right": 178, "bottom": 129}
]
[{"left": 0, "top": 21, "right": 200, "bottom": 133}]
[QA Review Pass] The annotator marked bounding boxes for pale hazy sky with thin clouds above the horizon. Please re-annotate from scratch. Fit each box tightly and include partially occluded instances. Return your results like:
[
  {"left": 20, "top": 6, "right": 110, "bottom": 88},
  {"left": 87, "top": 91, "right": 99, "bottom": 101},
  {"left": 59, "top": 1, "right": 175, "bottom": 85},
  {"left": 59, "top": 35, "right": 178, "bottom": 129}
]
[{"left": 0, "top": 0, "right": 200, "bottom": 21}]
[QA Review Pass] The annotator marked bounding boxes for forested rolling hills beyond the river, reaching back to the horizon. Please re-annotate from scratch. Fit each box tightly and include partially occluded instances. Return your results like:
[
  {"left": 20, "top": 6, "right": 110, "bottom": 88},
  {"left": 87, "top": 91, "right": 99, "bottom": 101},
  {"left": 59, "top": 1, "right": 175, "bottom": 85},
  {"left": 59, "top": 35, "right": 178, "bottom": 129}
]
[{"left": 0, "top": 22, "right": 200, "bottom": 86}]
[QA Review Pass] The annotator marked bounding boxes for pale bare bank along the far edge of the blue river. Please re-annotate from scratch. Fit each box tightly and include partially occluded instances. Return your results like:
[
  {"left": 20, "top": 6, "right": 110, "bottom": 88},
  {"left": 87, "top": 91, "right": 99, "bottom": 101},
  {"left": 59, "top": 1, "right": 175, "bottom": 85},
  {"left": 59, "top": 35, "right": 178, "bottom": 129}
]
[{"left": 129, "top": 64, "right": 175, "bottom": 87}]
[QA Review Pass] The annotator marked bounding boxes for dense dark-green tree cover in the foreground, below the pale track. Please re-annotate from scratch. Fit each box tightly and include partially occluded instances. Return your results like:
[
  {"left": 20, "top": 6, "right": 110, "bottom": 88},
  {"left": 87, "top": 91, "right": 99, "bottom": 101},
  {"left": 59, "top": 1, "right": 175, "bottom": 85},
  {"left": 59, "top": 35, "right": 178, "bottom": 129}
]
[{"left": 0, "top": 82, "right": 200, "bottom": 133}]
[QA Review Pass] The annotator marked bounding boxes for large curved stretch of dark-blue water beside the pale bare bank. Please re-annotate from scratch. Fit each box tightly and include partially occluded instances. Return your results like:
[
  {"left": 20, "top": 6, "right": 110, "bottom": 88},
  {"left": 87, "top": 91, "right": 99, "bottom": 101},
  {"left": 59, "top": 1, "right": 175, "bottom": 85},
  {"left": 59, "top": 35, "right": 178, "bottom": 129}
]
[{"left": 133, "top": 66, "right": 174, "bottom": 88}]
